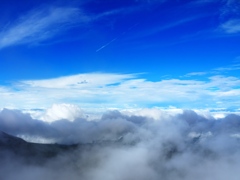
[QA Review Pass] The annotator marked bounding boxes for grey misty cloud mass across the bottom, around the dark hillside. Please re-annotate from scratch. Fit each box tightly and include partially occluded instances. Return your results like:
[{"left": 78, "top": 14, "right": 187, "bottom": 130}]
[{"left": 0, "top": 109, "right": 240, "bottom": 180}]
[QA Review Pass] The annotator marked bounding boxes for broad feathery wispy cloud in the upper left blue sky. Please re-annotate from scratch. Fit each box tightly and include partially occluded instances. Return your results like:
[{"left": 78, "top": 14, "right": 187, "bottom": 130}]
[{"left": 0, "top": 7, "right": 89, "bottom": 48}]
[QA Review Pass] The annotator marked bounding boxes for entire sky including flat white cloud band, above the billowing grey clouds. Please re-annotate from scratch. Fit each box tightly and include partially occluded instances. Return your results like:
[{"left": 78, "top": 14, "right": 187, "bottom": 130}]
[{"left": 0, "top": 0, "right": 240, "bottom": 111}]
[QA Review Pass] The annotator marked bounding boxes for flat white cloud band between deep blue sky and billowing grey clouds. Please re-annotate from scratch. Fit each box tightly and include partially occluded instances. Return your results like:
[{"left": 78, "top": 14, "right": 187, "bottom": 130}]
[{"left": 0, "top": 73, "right": 240, "bottom": 109}]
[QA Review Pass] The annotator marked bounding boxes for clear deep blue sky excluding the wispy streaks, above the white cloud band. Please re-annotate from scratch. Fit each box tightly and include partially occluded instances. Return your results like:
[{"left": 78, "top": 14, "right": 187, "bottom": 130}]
[{"left": 0, "top": 0, "right": 240, "bottom": 80}]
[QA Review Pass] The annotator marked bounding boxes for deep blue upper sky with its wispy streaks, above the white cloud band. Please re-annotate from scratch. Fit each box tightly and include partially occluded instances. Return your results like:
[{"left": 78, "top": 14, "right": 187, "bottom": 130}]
[{"left": 0, "top": 0, "right": 240, "bottom": 110}]
